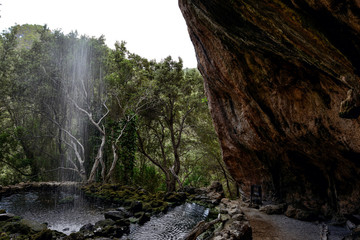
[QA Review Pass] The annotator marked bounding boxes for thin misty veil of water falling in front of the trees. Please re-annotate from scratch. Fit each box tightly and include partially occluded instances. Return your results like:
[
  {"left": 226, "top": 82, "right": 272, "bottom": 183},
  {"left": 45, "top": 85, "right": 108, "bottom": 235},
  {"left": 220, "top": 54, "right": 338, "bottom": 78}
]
[{"left": 59, "top": 37, "right": 103, "bottom": 181}]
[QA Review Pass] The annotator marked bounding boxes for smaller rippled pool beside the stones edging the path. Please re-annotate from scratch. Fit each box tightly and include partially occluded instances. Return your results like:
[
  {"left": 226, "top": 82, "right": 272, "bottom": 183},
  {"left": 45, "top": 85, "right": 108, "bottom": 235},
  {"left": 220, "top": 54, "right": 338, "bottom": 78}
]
[{"left": 122, "top": 203, "right": 209, "bottom": 240}]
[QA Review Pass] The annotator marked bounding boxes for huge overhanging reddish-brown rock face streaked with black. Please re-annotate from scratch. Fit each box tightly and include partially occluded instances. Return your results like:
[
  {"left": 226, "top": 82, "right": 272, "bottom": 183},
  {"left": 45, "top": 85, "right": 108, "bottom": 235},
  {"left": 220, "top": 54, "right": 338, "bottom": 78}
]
[{"left": 179, "top": 0, "right": 360, "bottom": 215}]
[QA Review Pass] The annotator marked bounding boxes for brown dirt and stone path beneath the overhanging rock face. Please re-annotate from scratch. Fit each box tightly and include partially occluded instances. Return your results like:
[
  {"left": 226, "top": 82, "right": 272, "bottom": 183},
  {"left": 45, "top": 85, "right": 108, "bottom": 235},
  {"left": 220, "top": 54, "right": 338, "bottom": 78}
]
[{"left": 243, "top": 202, "right": 360, "bottom": 240}]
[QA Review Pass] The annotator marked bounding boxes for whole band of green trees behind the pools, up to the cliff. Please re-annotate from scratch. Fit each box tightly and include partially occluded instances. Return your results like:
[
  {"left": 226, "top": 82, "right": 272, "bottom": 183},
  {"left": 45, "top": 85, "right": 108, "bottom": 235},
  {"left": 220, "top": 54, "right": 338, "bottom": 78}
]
[{"left": 0, "top": 25, "right": 236, "bottom": 196}]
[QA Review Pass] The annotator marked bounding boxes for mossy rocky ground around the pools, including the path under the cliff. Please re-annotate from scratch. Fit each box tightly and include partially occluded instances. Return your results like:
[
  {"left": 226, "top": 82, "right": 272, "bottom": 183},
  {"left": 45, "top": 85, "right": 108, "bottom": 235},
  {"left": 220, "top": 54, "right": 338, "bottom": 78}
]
[{"left": 0, "top": 183, "right": 360, "bottom": 240}]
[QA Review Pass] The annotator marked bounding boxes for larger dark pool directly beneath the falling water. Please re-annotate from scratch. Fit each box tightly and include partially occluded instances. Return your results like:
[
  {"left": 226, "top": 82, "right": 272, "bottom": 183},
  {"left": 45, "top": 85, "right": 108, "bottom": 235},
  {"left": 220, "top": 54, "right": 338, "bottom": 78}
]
[{"left": 0, "top": 191, "right": 108, "bottom": 234}]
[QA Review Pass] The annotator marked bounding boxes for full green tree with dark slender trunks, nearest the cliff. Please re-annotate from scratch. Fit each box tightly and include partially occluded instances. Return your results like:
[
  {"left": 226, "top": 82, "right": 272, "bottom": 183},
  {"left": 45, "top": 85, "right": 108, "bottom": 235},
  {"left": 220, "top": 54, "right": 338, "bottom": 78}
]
[{"left": 138, "top": 57, "right": 203, "bottom": 192}]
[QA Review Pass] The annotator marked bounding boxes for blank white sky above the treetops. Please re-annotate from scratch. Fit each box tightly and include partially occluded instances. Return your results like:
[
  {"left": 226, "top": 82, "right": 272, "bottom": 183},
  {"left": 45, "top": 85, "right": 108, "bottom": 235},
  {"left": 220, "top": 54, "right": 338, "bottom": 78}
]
[{"left": 0, "top": 0, "right": 197, "bottom": 67}]
